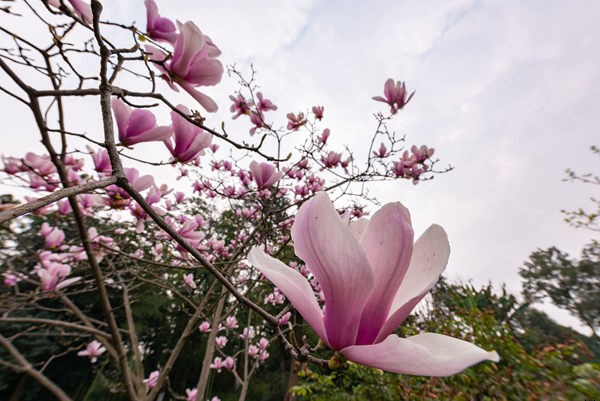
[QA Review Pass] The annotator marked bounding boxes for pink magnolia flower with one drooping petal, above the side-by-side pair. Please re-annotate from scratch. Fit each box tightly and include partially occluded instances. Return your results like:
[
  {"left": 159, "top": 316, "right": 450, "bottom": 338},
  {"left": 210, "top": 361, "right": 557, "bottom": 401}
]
[{"left": 146, "top": 21, "right": 223, "bottom": 112}]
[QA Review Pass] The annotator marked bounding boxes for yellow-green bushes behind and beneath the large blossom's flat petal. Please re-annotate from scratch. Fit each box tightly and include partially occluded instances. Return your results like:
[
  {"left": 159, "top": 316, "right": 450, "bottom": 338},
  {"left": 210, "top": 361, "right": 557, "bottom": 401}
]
[{"left": 293, "top": 280, "right": 600, "bottom": 401}]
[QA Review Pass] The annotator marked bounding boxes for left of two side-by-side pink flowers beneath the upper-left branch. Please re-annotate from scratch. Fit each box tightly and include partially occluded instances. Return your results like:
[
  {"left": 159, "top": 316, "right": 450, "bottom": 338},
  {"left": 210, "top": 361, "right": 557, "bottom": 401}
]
[{"left": 111, "top": 97, "right": 171, "bottom": 146}]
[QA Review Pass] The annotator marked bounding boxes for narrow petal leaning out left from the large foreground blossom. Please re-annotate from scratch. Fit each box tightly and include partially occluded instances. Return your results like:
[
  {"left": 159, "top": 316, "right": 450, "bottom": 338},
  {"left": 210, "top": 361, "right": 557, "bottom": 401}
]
[{"left": 248, "top": 247, "right": 329, "bottom": 344}]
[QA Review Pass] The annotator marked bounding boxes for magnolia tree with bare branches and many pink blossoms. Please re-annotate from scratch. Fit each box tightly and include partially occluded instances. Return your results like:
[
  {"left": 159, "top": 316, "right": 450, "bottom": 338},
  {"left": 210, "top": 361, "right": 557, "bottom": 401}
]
[{"left": 0, "top": 0, "right": 498, "bottom": 401}]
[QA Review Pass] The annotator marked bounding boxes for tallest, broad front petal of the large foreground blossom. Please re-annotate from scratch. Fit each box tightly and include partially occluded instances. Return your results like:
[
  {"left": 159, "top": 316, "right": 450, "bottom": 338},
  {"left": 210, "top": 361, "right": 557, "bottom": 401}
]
[{"left": 292, "top": 192, "right": 375, "bottom": 350}]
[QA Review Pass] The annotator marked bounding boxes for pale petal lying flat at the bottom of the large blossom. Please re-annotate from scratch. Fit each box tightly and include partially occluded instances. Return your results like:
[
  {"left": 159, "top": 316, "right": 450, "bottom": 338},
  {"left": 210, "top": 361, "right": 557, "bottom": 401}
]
[{"left": 341, "top": 333, "right": 500, "bottom": 376}]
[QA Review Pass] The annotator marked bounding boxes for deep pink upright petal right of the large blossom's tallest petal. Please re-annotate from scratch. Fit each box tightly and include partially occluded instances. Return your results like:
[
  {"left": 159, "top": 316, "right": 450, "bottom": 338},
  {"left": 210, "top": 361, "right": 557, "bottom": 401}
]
[{"left": 357, "top": 202, "right": 414, "bottom": 344}]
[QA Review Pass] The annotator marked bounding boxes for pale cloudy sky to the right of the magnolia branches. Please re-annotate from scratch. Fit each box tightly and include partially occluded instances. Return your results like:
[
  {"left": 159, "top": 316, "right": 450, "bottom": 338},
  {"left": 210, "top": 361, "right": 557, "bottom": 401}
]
[{"left": 0, "top": 0, "right": 600, "bottom": 328}]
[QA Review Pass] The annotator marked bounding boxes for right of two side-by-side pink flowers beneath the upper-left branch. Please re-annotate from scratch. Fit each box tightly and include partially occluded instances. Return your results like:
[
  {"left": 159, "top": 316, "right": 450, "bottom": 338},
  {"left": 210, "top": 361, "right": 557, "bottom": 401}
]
[{"left": 164, "top": 105, "right": 212, "bottom": 163}]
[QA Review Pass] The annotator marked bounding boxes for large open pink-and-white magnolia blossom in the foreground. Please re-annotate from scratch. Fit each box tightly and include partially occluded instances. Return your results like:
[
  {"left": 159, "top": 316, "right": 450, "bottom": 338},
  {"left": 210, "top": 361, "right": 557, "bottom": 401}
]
[{"left": 248, "top": 193, "right": 499, "bottom": 376}]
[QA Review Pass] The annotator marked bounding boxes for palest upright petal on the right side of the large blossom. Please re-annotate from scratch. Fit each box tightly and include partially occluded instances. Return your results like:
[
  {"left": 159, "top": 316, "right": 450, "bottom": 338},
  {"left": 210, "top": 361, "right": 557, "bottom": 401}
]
[{"left": 376, "top": 224, "right": 450, "bottom": 341}]
